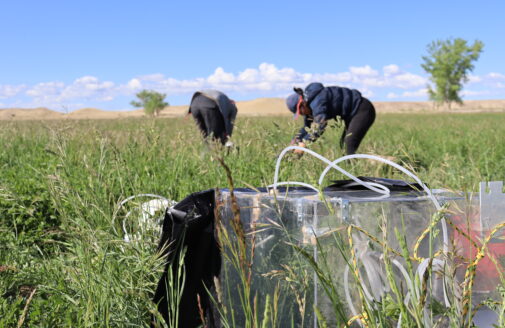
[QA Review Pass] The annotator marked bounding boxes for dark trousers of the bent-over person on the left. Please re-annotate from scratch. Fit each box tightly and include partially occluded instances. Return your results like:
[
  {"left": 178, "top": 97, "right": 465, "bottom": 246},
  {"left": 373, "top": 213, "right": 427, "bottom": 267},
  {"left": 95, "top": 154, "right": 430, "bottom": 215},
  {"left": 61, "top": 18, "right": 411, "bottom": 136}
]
[{"left": 191, "top": 95, "right": 226, "bottom": 144}]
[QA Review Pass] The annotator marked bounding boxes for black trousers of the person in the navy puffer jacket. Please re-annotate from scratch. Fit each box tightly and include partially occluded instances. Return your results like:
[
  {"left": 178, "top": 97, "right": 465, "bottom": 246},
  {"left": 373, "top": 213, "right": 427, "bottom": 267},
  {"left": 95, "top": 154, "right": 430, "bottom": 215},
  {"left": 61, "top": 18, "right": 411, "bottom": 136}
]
[{"left": 340, "top": 98, "right": 375, "bottom": 155}]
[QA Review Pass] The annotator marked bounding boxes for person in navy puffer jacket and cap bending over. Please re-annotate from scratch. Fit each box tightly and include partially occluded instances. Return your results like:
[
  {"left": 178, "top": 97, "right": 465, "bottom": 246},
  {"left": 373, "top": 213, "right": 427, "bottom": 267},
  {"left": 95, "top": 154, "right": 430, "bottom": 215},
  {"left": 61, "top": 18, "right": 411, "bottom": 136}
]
[{"left": 286, "top": 82, "right": 375, "bottom": 155}]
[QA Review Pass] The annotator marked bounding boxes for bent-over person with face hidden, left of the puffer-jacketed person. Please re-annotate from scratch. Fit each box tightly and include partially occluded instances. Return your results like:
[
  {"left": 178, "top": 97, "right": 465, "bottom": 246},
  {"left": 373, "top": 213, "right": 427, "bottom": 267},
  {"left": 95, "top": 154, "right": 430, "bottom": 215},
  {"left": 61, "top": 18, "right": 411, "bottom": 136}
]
[{"left": 188, "top": 90, "right": 237, "bottom": 145}]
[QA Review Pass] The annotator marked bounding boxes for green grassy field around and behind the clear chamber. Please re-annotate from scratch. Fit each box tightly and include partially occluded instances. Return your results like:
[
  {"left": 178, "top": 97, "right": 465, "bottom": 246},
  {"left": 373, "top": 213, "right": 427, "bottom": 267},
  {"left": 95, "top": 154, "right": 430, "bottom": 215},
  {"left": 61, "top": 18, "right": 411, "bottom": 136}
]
[{"left": 0, "top": 114, "right": 505, "bottom": 327}]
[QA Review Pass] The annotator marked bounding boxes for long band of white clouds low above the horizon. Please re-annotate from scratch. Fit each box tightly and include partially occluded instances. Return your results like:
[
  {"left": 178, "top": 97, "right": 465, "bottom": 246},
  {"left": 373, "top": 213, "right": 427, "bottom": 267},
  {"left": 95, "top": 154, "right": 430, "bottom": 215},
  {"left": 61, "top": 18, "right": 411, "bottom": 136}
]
[{"left": 0, "top": 63, "right": 505, "bottom": 108}]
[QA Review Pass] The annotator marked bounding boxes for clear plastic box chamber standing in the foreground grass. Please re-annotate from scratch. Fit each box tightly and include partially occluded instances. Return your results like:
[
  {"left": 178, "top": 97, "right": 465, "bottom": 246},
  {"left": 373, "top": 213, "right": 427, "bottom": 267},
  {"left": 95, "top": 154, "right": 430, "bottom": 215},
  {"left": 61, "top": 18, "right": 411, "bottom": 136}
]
[{"left": 216, "top": 188, "right": 505, "bottom": 327}]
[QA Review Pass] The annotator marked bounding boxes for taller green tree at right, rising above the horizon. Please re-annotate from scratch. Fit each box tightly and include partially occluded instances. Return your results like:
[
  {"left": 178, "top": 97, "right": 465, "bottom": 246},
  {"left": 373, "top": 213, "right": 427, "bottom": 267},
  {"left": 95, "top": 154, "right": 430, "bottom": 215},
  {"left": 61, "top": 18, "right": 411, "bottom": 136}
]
[{"left": 421, "top": 38, "right": 484, "bottom": 109}]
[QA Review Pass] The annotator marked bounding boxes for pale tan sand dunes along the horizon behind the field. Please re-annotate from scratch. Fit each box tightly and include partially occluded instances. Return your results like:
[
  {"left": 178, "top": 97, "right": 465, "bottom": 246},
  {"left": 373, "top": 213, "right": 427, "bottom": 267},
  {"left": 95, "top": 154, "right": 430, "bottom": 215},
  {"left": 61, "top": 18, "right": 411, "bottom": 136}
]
[{"left": 0, "top": 98, "right": 505, "bottom": 121}]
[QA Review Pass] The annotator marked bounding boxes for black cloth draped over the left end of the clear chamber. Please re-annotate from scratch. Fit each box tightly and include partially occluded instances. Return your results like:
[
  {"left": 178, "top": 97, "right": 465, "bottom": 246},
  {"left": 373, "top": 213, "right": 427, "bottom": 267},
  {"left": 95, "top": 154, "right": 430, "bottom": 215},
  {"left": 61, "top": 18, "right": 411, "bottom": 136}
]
[{"left": 153, "top": 189, "right": 221, "bottom": 328}]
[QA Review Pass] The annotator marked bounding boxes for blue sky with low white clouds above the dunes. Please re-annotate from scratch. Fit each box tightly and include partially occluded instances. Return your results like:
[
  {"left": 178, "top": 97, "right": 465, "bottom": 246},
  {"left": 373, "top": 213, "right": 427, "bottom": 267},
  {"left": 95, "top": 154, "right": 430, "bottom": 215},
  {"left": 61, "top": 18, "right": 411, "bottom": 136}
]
[{"left": 0, "top": 0, "right": 505, "bottom": 111}]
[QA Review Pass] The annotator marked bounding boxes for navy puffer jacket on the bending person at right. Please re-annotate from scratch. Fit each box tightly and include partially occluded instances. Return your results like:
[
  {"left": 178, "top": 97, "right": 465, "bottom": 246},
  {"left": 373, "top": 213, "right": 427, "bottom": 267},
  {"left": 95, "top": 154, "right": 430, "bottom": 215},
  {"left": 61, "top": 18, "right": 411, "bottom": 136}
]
[{"left": 295, "top": 82, "right": 362, "bottom": 141}]
